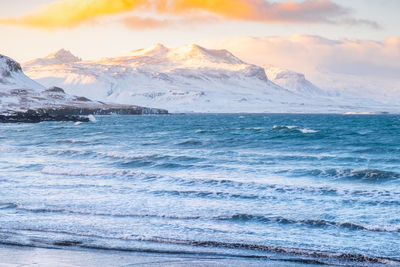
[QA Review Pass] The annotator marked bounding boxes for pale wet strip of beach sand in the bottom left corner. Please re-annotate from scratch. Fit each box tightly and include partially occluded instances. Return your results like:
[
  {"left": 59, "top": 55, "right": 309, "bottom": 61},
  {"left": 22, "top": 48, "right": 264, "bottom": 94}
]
[{"left": 0, "top": 245, "right": 322, "bottom": 267}]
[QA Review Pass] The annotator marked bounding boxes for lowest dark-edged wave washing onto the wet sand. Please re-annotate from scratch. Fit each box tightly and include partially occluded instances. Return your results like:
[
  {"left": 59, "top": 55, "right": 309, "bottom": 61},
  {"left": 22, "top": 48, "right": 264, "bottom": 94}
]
[{"left": 0, "top": 228, "right": 400, "bottom": 266}]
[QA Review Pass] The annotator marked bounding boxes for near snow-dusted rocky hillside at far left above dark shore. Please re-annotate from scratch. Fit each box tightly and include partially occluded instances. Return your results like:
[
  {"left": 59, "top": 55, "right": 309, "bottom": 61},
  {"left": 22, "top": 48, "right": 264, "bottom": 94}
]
[{"left": 0, "top": 55, "right": 166, "bottom": 118}]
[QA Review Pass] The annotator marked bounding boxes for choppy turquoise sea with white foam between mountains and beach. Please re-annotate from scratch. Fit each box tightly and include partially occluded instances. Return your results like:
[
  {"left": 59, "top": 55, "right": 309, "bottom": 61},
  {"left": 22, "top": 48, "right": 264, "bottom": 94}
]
[{"left": 0, "top": 114, "right": 400, "bottom": 266}]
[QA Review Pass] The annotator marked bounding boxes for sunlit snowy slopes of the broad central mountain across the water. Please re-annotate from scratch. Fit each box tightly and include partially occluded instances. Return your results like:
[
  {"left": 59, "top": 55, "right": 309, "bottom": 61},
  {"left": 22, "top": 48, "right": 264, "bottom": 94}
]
[{"left": 24, "top": 44, "right": 396, "bottom": 112}]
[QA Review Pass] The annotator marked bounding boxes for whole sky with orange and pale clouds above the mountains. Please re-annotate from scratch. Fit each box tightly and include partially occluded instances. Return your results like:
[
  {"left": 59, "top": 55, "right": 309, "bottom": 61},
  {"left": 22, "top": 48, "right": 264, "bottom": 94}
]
[{"left": 0, "top": 0, "right": 400, "bottom": 62}]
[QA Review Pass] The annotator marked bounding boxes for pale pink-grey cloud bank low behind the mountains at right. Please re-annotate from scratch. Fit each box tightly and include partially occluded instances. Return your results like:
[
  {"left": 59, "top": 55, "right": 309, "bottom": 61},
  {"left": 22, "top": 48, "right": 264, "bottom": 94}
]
[{"left": 200, "top": 34, "right": 400, "bottom": 105}]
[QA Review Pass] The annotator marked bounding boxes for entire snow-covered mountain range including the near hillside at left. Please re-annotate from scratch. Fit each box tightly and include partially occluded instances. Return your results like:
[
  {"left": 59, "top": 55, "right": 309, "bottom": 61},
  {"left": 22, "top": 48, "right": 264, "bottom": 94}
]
[{"left": 0, "top": 44, "right": 398, "bottom": 113}]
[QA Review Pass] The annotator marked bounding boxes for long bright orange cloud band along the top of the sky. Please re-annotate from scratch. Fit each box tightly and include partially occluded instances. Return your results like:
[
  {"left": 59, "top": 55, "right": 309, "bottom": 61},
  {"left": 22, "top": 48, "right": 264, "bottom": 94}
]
[{"left": 0, "top": 0, "right": 377, "bottom": 29}]
